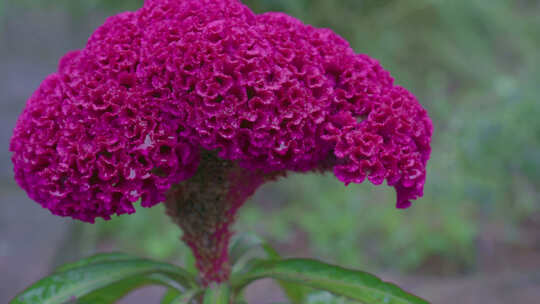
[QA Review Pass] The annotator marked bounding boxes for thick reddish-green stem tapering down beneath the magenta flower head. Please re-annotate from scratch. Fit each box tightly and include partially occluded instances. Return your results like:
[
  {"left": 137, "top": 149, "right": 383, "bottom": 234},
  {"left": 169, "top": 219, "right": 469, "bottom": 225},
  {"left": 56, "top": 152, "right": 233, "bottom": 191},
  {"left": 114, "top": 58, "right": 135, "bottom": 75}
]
[{"left": 161, "top": 152, "right": 270, "bottom": 287}]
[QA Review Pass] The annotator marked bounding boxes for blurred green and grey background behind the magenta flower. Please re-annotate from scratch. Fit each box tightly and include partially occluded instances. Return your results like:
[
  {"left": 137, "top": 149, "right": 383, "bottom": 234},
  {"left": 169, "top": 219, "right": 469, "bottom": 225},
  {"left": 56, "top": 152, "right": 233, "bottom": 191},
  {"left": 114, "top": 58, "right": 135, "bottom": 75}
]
[{"left": 0, "top": 0, "right": 540, "bottom": 304}]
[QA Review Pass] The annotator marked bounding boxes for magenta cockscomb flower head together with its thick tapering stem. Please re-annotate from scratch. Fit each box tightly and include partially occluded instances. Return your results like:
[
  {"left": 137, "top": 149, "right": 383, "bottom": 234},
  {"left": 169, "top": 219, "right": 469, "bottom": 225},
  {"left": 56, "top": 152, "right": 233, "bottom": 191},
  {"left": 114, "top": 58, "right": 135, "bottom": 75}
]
[{"left": 10, "top": 0, "right": 432, "bottom": 282}]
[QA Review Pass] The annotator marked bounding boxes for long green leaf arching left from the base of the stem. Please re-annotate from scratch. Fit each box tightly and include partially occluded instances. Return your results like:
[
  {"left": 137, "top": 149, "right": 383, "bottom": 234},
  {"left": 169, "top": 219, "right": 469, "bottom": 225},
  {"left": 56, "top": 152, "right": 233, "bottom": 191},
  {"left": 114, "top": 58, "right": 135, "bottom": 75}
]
[{"left": 11, "top": 259, "right": 195, "bottom": 304}]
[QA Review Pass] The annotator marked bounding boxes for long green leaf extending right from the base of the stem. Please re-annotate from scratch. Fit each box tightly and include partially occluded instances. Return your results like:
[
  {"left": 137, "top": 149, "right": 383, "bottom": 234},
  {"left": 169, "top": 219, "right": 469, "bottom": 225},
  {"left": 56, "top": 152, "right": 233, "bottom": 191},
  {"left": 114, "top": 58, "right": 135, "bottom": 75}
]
[{"left": 231, "top": 259, "right": 428, "bottom": 304}]
